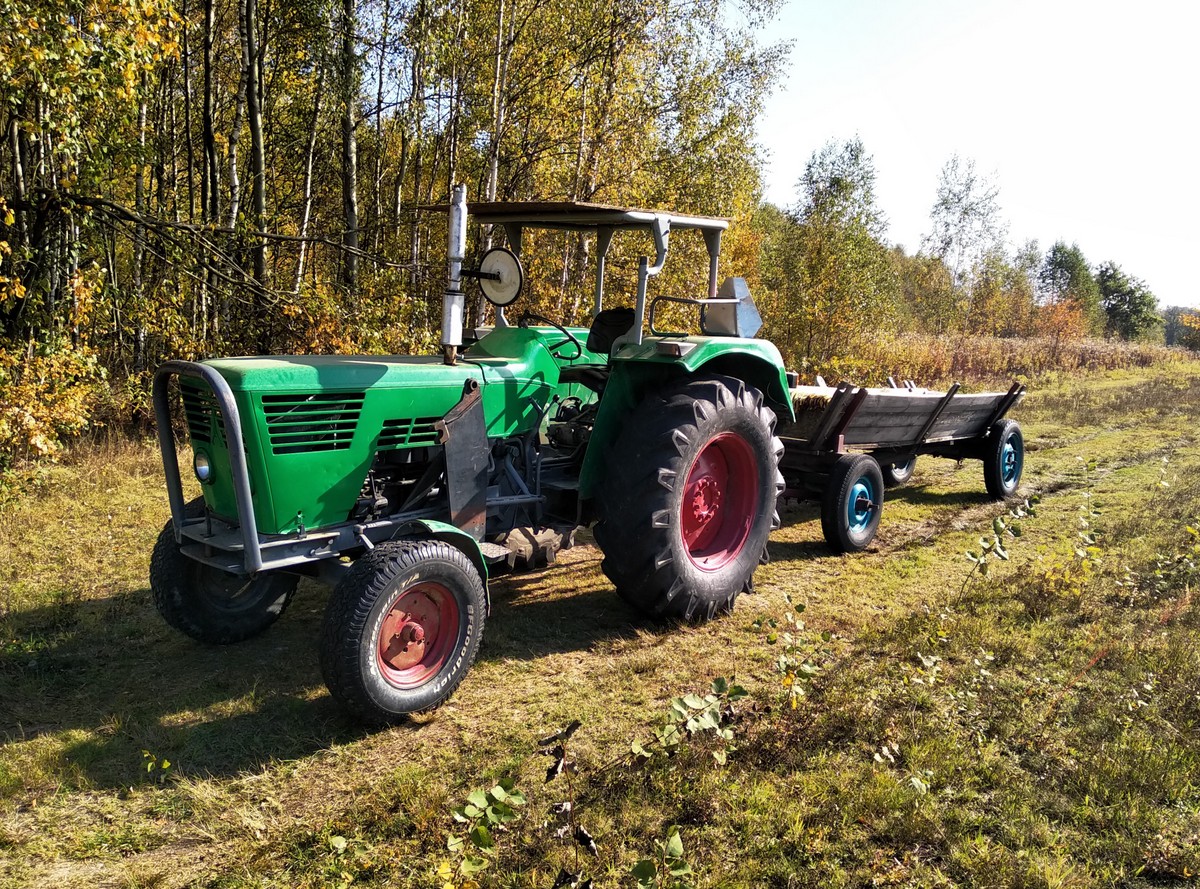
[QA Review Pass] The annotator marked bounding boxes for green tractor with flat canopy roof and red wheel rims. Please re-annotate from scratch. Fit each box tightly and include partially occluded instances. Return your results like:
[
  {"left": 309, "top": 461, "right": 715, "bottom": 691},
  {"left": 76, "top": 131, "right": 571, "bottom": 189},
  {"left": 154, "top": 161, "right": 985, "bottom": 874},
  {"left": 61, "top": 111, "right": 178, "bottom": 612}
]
[{"left": 150, "top": 186, "right": 793, "bottom": 723}]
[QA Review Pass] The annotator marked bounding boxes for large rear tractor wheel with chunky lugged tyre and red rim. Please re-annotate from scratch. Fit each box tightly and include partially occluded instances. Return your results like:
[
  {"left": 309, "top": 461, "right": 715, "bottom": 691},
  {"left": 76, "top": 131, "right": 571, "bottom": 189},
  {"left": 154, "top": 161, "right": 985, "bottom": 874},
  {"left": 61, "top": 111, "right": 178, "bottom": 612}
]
[{"left": 595, "top": 376, "right": 784, "bottom": 620}]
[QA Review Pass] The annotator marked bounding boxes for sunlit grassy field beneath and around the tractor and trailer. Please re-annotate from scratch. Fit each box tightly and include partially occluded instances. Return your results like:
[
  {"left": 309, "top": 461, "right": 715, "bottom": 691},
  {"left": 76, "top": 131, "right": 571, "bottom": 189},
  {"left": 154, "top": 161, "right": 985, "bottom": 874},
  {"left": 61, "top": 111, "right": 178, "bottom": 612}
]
[{"left": 0, "top": 364, "right": 1200, "bottom": 889}]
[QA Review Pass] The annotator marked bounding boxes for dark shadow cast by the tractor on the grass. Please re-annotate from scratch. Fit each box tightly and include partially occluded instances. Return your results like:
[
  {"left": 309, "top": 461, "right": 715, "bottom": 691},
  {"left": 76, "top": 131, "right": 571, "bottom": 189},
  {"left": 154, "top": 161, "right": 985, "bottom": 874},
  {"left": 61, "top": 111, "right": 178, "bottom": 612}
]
[{"left": 0, "top": 559, "right": 648, "bottom": 789}]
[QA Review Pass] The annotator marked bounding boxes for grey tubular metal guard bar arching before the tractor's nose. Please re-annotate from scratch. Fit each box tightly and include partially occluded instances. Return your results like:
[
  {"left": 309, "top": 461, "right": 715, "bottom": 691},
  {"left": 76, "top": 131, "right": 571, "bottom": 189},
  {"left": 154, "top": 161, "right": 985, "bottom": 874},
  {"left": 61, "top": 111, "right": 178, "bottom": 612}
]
[{"left": 154, "top": 361, "right": 263, "bottom": 575}]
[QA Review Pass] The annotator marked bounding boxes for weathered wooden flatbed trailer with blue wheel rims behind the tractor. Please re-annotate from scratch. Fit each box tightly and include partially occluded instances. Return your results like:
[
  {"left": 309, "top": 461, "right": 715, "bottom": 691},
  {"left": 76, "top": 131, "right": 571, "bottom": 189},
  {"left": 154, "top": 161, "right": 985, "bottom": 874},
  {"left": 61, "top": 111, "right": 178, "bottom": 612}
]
[{"left": 779, "top": 378, "right": 1025, "bottom": 553}]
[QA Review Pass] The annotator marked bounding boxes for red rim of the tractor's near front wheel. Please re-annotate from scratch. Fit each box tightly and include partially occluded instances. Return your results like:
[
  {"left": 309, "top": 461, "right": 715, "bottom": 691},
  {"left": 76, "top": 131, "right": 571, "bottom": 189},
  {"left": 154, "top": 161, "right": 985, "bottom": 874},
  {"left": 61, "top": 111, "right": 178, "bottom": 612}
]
[{"left": 376, "top": 582, "right": 458, "bottom": 689}]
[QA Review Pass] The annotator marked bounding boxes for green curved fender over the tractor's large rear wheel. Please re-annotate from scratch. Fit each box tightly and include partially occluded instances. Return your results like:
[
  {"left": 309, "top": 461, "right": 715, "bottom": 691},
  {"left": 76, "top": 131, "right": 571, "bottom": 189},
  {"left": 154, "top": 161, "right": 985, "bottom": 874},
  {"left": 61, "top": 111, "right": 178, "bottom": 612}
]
[{"left": 580, "top": 337, "right": 796, "bottom": 499}]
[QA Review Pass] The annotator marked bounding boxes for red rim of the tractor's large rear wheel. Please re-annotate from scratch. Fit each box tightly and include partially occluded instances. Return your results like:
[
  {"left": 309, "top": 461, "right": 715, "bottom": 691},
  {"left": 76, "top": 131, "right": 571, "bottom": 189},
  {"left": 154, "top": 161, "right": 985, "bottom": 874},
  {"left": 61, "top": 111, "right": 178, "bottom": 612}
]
[{"left": 679, "top": 432, "right": 758, "bottom": 571}]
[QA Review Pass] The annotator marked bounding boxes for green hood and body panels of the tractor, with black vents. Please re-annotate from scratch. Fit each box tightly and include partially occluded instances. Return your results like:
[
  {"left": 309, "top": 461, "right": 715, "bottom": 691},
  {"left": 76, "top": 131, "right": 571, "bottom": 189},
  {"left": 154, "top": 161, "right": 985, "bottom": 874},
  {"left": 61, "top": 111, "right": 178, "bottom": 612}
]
[{"left": 184, "top": 328, "right": 604, "bottom": 534}]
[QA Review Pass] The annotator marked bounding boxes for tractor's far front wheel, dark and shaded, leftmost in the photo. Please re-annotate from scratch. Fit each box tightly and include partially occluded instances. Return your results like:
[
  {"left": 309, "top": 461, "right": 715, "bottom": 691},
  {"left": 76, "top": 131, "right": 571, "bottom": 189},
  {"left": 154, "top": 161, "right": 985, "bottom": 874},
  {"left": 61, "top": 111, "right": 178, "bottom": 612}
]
[{"left": 150, "top": 499, "right": 300, "bottom": 645}]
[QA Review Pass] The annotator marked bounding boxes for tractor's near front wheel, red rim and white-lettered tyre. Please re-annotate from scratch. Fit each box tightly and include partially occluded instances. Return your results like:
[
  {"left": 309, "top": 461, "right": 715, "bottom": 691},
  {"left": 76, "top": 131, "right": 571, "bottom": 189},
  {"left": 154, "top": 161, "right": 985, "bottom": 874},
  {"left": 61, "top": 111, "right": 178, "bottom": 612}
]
[{"left": 320, "top": 540, "right": 487, "bottom": 725}]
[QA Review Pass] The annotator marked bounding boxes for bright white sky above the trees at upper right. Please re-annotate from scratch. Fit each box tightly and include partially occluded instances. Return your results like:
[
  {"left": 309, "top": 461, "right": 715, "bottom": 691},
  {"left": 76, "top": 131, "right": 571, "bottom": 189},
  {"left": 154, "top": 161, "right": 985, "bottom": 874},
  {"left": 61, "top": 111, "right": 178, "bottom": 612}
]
[{"left": 758, "top": 0, "right": 1200, "bottom": 307}]
